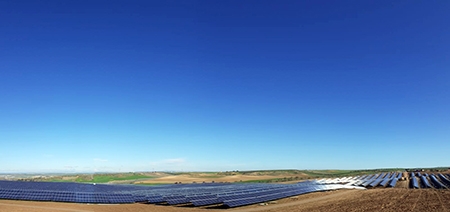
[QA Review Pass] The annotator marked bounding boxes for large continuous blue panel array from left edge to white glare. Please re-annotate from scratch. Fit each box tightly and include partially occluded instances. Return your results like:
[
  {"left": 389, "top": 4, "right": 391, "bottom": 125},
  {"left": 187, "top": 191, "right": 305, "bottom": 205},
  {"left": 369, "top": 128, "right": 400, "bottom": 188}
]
[{"left": 0, "top": 181, "right": 353, "bottom": 207}]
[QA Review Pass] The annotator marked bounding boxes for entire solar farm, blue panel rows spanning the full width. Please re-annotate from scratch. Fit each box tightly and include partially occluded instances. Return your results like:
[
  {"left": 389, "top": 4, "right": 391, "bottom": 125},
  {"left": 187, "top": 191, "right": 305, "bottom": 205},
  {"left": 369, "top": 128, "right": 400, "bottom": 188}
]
[{"left": 0, "top": 172, "right": 450, "bottom": 210}]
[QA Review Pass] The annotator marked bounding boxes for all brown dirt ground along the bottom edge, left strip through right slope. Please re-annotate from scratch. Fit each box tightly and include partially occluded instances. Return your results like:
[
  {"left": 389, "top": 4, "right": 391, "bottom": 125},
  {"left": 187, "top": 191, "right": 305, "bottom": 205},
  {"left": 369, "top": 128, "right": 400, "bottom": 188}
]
[{"left": 0, "top": 188, "right": 450, "bottom": 212}]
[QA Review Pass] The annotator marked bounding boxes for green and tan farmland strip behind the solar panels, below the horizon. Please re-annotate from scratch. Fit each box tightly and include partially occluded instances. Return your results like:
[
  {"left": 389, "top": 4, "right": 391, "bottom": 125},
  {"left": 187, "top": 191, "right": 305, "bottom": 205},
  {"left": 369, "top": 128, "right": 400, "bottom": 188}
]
[{"left": 39, "top": 169, "right": 408, "bottom": 185}]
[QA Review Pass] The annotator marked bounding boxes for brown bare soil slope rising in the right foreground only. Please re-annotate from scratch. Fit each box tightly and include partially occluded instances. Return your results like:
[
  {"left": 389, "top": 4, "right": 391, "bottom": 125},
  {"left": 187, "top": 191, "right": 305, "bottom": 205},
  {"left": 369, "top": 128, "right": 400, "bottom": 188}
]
[{"left": 241, "top": 189, "right": 450, "bottom": 212}]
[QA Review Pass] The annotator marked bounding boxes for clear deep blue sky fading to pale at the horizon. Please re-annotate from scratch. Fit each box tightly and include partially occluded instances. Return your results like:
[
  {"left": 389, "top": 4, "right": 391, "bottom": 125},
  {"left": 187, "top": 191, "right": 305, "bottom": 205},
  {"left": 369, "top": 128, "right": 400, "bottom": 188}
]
[{"left": 0, "top": 0, "right": 450, "bottom": 172}]
